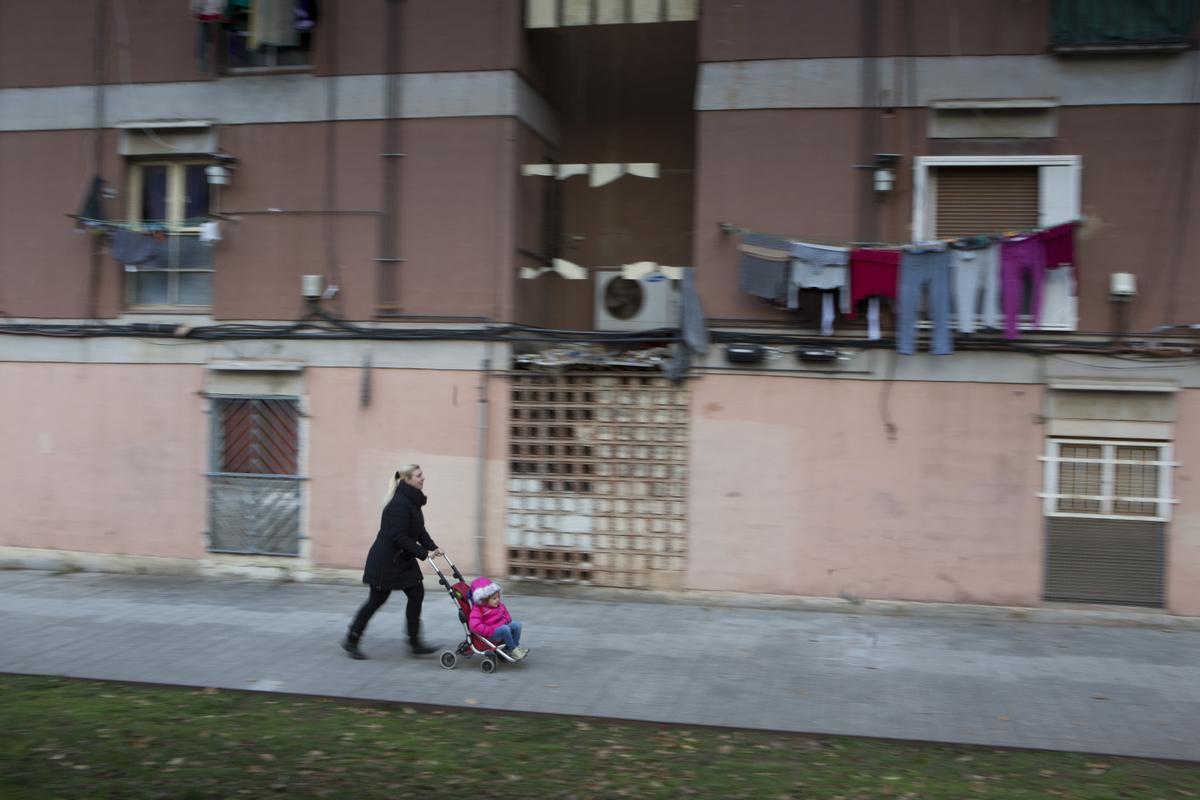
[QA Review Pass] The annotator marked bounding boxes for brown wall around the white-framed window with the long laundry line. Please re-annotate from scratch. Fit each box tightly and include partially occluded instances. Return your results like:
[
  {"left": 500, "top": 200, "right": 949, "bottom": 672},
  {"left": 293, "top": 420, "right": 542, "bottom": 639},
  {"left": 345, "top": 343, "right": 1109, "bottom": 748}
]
[{"left": 696, "top": 106, "right": 1200, "bottom": 331}]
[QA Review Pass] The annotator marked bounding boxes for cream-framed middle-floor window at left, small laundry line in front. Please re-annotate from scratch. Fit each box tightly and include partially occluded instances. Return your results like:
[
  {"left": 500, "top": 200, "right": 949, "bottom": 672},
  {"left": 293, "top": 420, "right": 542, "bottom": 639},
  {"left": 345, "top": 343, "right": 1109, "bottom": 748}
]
[{"left": 125, "top": 161, "right": 212, "bottom": 308}]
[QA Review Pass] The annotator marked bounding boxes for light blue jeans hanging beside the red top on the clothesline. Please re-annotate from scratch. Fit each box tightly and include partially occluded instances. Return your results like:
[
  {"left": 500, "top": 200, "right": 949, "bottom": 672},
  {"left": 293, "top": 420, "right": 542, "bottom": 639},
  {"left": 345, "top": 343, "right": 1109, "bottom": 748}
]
[{"left": 896, "top": 243, "right": 954, "bottom": 355}]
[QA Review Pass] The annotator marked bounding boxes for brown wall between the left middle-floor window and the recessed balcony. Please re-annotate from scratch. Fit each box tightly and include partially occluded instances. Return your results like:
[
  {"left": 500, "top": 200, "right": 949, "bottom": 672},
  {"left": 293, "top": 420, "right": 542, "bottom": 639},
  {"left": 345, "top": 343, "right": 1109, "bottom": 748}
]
[{"left": 215, "top": 118, "right": 516, "bottom": 319}]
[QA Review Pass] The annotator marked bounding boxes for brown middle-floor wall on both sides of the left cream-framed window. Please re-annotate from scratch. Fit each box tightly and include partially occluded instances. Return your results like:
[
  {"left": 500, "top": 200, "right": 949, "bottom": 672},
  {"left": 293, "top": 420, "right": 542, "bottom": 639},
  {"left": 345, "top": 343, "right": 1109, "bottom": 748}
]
[{"left": 0, "top": 118, "right": 520, "bottom": 319}]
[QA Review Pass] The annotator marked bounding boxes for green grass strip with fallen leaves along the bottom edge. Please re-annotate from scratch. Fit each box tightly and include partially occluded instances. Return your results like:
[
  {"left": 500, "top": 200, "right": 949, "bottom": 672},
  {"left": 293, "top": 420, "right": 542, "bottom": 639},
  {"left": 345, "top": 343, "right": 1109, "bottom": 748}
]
[{"left": 0, "top": 675, "right": 1200, "bottom": 800}]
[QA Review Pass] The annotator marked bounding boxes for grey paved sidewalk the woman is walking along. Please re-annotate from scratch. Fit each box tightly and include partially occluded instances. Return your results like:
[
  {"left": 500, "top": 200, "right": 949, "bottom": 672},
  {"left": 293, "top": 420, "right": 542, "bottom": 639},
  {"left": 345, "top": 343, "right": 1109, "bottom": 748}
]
[{"left": 0, "top": 571, "right": 1200, "bottom": 760}]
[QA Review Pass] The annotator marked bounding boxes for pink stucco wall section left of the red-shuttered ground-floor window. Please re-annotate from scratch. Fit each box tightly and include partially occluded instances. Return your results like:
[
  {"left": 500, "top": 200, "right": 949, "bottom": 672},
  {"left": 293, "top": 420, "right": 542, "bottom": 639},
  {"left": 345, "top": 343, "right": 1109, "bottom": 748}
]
[{"left": 0, "top": 363, "right": 208, "bottom": 558}]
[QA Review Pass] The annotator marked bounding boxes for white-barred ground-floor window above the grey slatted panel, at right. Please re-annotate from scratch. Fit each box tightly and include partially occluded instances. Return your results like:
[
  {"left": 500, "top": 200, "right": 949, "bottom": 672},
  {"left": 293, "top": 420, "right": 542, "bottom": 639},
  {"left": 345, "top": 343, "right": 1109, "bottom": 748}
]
[{"left": 1042, "top": 439, "right": 1176, "bottom": 522}]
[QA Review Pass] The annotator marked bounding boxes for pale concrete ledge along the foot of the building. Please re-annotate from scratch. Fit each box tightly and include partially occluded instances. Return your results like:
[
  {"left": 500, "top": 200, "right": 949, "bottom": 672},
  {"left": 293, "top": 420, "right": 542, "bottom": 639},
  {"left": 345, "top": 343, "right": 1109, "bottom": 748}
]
[{"left": 0, "top": 547, "right": 1200, "bottom": 631}]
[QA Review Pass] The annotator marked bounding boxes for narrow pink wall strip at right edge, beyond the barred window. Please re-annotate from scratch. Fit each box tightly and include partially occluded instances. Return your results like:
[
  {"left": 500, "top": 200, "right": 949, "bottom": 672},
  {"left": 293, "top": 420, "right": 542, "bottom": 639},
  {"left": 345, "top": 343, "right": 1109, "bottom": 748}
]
[{"left": 1166, "top": 390, "right": 1200, "bottom": 615}]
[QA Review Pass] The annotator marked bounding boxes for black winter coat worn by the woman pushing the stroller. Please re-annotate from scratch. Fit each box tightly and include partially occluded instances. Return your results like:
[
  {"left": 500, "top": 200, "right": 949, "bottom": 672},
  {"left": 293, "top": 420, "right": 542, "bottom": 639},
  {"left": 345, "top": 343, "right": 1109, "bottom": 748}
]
[{"left": 362, "top": 482, "right": 438, "bottom": 589}]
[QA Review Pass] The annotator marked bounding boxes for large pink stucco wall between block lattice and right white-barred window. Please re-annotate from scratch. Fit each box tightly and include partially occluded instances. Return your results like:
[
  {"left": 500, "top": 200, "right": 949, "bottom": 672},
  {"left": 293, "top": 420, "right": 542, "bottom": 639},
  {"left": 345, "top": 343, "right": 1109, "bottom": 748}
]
[{"left": 688, "top": 375, "right": 1043, "bottom": 604}]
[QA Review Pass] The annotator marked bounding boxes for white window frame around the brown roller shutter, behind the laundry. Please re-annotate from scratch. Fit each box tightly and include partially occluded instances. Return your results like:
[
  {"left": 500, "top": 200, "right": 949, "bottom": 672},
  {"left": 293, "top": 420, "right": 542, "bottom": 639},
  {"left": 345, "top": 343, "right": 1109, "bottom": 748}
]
[{"left": 912, "top": 156, "right": 1082, "bottom": 331}]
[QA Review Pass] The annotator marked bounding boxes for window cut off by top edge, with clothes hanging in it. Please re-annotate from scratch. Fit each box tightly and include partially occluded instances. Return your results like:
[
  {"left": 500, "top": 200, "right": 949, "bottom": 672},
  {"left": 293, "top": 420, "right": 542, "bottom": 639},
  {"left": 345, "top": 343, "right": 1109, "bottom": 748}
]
[{"left": 222, "top": 0, "right": 316, "bottom": 71}]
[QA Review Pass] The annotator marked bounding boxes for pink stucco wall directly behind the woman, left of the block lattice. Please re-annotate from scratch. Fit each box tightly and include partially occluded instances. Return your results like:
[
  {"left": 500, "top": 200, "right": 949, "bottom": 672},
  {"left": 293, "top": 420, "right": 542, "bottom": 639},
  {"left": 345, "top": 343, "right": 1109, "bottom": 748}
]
[{"left": 306, "top": 368, "right": 508, "bottom": 572}]
